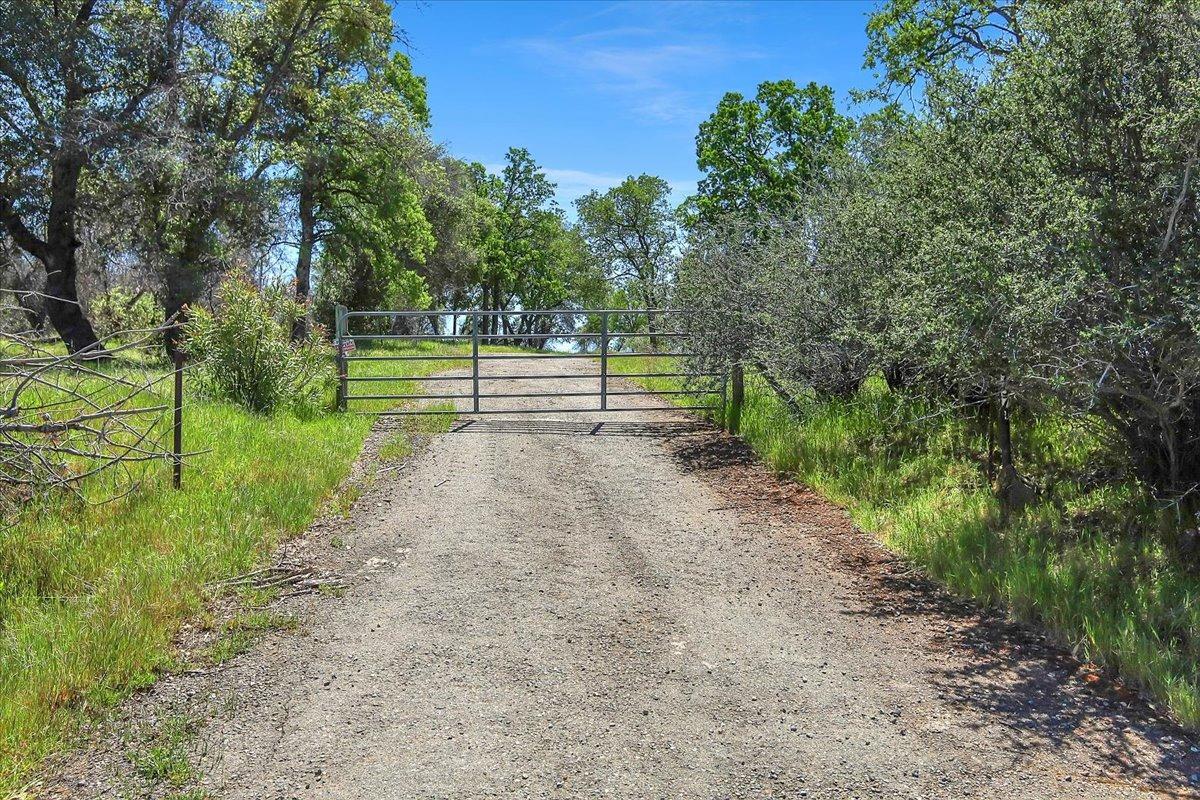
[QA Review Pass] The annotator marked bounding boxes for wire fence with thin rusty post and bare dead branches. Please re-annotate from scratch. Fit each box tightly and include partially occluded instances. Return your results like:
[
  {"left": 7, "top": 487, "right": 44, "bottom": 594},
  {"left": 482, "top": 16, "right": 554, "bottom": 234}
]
[{"left": 0, "top": 289, "right": 184, "bottom": 521}]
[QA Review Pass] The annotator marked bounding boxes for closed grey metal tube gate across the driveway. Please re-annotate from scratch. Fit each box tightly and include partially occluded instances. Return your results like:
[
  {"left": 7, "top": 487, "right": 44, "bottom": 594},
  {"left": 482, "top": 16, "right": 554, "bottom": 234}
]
[{"left": 335, "top": 306, "right": 726, "bottom": 416}]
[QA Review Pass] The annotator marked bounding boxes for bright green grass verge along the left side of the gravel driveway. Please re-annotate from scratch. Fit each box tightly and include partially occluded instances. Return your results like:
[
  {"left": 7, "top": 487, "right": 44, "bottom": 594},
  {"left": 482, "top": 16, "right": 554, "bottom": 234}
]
[{"left": 0, "top": 345, "right": 461, "bottom": 796}]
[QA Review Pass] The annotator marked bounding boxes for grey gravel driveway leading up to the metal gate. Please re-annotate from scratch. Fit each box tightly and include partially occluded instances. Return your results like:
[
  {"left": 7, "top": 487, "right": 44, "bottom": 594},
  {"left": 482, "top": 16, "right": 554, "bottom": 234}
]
[{"left": 60, "top": 361, "right": 1200, "bottom": 800}]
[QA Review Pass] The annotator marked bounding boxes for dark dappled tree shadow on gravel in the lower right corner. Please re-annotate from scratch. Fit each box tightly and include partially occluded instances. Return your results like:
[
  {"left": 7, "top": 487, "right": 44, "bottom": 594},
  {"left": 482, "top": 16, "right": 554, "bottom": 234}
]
[{"left": 842, "top": 553, "right": 1200, "bottom": 798}]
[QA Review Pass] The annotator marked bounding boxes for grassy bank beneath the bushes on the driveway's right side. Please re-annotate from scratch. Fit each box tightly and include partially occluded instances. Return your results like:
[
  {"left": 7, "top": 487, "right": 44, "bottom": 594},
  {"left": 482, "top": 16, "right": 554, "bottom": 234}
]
[{"left": 618, "top": 360, "right": 1200, "bottom": 728}]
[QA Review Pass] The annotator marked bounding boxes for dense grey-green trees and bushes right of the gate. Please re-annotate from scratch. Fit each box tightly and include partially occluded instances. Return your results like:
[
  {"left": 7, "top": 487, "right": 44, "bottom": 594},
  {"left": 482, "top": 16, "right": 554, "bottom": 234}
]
[{"left": 678, "top": 0, "right": 1200, "bottom": 510}]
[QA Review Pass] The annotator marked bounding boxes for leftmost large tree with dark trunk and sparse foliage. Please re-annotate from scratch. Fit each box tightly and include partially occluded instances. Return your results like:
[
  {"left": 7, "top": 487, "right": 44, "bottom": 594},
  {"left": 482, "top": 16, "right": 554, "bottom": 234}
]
[{"left": 0, "top": 0, "right": 202, "bottom": 351}]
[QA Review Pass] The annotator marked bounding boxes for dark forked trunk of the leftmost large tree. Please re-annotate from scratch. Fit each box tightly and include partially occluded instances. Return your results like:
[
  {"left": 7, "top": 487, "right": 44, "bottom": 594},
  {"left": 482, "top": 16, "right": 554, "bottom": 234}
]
[{"left": 0, "top": 151, "right": 103, "bottom": 356}]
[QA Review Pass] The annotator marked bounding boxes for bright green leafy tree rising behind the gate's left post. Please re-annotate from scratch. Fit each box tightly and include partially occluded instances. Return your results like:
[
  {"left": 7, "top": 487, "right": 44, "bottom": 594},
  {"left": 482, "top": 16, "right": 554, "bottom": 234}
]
[{"left": 286, "top": 43, "right": 442, "bottom": 319}]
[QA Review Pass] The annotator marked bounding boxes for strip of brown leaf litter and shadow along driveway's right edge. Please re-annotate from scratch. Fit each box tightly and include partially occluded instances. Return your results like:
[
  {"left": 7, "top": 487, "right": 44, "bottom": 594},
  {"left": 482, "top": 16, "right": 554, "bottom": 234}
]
[{"left": 673, "top": 429, "right": 1200, "bottom": 798}]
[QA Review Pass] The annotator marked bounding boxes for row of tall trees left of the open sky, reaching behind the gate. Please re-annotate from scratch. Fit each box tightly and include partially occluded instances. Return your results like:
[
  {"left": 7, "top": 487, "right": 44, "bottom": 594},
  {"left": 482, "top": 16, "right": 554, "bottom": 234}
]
[{"left": 0, "top": 0, "right": 676, "bottom": 351}]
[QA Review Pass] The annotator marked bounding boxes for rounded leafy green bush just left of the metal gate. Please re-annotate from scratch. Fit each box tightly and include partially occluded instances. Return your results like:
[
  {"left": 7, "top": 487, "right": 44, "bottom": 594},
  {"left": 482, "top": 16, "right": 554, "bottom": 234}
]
[{"left": 184, "top": 277, "right": 335, "bottom": 414}]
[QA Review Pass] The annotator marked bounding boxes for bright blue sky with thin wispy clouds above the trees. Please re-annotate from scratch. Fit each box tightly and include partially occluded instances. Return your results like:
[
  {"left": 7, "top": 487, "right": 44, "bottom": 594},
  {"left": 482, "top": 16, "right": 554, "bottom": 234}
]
[{"left": 394, "top": 0, "right": 874, "bottom": 207}]
